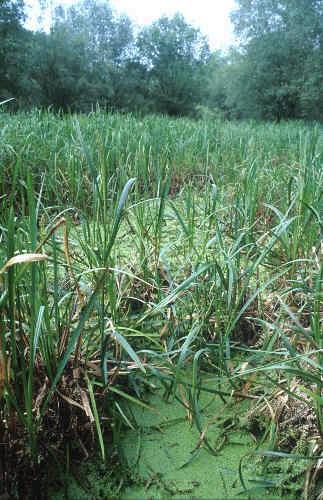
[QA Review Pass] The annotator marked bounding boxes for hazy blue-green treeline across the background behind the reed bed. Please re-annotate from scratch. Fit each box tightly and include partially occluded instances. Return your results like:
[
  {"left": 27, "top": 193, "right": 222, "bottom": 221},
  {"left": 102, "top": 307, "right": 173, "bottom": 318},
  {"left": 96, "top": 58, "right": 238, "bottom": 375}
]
[{"left": 0, "top": 0, "right": 323, "bottom": 121}]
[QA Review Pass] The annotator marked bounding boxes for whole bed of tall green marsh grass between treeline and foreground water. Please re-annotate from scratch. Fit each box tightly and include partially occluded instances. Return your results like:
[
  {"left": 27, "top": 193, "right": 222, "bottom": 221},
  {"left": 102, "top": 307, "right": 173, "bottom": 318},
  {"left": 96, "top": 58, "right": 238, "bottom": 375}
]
[{"left": 0, "top": 111, "right": 323, "bottom": 498}]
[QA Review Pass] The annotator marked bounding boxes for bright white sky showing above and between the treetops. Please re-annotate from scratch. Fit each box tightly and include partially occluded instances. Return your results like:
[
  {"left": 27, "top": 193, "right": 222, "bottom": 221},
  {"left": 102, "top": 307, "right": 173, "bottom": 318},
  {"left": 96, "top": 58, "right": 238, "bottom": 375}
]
[{"left": 26, "top": 0, "right": 235, "bottom": 49}]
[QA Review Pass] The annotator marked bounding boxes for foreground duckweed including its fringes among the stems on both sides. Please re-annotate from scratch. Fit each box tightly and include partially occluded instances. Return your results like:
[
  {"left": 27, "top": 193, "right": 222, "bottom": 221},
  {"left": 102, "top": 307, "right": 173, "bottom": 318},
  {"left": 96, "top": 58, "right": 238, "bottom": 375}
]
[{"left": 50, "top": 377, "right": 310, "bottom": 500}]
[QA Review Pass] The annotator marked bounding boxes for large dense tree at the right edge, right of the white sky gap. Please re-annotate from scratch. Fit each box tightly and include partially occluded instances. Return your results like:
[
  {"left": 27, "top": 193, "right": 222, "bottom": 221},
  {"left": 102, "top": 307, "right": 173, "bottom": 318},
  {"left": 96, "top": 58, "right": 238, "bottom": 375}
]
[{"left": 228, "top": 0, "right": 323, "bottom": 120}]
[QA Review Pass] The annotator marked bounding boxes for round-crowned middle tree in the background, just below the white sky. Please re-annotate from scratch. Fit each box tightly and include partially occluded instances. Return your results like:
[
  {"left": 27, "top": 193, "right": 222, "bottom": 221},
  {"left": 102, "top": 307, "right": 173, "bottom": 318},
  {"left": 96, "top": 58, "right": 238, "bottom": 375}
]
[{"left": 137, "top": 14, "right": 210, "bottom": 115}]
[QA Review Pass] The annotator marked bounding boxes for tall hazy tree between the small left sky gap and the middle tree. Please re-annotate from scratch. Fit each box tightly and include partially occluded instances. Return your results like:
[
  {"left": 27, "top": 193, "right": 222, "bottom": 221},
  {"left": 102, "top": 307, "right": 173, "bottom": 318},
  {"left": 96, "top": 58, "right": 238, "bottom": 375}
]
[{"left": 33, "top": 0, "right": 137, "bottom": 111}]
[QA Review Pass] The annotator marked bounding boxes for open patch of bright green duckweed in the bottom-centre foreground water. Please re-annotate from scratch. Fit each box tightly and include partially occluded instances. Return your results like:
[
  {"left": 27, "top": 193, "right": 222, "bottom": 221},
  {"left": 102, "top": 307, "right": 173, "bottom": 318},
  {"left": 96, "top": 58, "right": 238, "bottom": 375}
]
[{"left": 121, "top": 378, "right": 255, "bottom": 499}]
